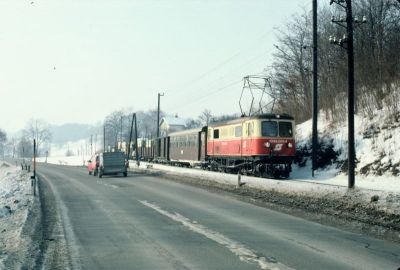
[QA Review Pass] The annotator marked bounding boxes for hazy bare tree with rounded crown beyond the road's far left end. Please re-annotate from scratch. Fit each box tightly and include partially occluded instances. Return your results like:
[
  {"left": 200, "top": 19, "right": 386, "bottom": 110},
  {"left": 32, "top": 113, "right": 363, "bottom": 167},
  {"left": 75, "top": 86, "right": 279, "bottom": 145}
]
[{"left": 22, "top": 119, "right": 52, "bottom": 155}]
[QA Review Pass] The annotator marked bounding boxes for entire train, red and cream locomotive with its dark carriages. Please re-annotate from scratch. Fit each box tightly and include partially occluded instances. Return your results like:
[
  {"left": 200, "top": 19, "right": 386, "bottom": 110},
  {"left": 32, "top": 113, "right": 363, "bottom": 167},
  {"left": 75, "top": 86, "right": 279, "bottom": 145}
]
[{"left": 138, "top": 114, "right": 296, "bottom": 178}]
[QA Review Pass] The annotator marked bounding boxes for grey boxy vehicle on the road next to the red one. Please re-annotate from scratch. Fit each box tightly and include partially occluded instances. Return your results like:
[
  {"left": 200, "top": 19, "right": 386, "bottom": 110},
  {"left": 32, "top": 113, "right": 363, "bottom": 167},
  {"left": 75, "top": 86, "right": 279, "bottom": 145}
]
[{"left": 98, "top": 152, "right": 128, "bottom": 178}]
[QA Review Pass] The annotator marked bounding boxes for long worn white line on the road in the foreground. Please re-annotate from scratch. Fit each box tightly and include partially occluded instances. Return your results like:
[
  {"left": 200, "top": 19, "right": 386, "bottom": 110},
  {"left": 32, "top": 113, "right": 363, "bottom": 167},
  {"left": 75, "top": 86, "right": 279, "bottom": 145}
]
[{"left": 139, "top": 201, "right": 294, "bottom": 270}]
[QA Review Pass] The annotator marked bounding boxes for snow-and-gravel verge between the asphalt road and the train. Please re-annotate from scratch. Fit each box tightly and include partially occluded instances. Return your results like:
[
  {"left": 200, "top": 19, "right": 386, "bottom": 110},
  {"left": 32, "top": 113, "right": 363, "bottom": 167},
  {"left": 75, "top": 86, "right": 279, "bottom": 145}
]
[{"left": 131, "top": 164, "right": 400, "bottom": 242}]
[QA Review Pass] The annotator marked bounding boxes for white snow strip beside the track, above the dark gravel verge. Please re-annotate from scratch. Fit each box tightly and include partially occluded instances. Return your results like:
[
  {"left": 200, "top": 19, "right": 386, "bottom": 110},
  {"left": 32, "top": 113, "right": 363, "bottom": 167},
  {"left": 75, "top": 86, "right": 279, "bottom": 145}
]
[{"left": 130, "top": 161, "right": 400, "bottom": 211}]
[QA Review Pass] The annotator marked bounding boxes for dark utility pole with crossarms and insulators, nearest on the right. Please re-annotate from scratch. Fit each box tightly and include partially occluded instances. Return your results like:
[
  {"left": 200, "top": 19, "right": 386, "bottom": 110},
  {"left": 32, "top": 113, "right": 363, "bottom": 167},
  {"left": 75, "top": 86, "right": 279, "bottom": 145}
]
[{"left": 329, "top": 0, "right": 367, "bottom": 188}]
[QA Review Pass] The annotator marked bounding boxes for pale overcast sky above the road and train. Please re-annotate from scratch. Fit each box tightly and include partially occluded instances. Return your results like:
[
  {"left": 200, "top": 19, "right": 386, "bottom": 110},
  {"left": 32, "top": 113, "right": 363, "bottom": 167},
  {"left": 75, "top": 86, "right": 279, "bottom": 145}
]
[{"left": 0, "top": 0, "right": 311, "bottom": 132}]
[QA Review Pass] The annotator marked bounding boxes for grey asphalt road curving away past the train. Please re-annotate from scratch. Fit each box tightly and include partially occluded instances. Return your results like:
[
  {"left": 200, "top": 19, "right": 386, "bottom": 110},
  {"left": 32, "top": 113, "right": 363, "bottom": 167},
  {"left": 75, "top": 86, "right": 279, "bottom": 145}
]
[{"left": 37, "top": 164, "right": 400, "bottom": 270}]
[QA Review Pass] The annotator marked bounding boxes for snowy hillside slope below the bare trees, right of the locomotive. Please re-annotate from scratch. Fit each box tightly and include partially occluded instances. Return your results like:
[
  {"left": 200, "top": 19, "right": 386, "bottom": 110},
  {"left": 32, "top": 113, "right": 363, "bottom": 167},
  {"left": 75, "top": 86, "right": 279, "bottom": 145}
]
[{"left": 296, "top": 110, "right": 400, "bottom": 177}]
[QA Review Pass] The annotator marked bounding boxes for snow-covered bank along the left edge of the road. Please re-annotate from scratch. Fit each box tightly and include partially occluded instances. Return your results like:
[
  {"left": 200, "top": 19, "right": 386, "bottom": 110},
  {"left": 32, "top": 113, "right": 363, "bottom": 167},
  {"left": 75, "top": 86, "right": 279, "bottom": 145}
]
[{"left": 0, "top": 161, "right": 34, "bottom": 269}]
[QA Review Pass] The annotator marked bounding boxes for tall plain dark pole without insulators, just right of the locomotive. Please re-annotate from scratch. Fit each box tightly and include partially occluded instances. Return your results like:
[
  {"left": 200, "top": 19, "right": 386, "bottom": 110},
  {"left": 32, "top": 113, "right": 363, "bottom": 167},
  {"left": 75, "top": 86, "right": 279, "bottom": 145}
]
[{"left": 312, "top": 0, "right": 318, "bottom": 177}]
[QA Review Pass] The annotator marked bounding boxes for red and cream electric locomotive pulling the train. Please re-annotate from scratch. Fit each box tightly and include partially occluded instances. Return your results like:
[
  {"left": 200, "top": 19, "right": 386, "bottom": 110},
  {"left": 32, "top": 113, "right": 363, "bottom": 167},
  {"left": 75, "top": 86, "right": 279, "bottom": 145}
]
[{"left": 207, "top": 114, "right": 295, "bottom": 178}]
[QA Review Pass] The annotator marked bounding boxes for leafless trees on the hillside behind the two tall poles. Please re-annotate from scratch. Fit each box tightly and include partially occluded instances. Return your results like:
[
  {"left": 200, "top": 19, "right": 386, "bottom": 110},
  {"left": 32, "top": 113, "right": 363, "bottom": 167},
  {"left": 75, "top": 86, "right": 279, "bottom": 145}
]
[{"left": 271, "top": 0, "right": 400, "bottom": 122}]
